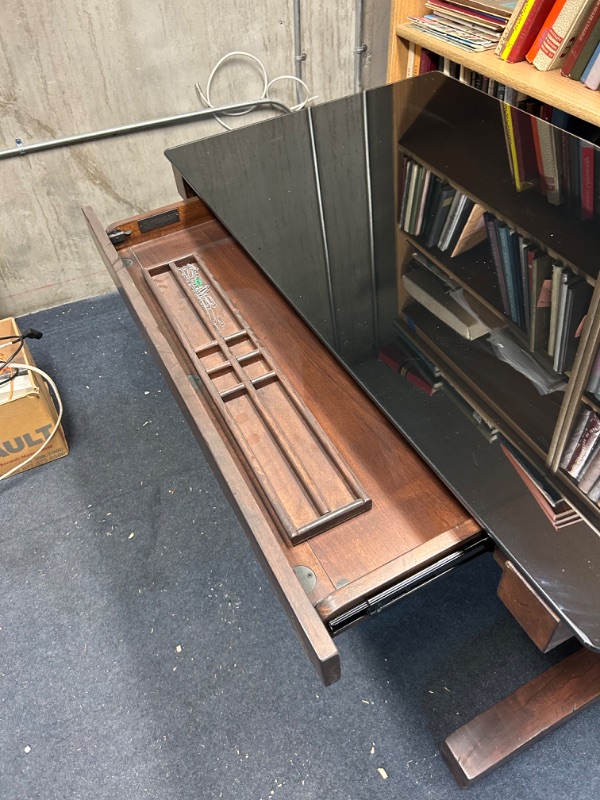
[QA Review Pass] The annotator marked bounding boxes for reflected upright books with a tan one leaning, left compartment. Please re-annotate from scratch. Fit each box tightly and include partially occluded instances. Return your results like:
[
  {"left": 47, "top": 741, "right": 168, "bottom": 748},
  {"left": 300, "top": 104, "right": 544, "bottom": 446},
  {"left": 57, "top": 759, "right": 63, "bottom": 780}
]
[{"left": 399, "top": 157, "right": 486, "bottom": 258}]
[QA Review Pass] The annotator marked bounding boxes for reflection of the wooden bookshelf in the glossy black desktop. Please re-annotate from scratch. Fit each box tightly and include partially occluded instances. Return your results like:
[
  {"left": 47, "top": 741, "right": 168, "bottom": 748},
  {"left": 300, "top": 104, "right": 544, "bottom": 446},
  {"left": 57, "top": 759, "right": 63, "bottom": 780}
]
[{"left": 396, "top": 73, "right": 600, "bottom": 532}]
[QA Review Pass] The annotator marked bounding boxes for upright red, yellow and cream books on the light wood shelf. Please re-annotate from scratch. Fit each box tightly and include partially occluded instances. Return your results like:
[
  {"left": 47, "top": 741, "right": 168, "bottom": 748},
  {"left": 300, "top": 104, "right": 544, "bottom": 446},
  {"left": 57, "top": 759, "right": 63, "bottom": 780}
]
[{"left": 495, "top": 0, "right": 600, "bottom": 83}]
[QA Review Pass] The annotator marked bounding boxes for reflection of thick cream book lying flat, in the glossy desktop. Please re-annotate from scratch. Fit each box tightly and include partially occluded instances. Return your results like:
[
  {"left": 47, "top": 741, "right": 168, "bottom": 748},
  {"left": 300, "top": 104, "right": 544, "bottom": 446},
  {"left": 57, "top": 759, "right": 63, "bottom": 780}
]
[{"left": 402, "top": 267, "right": 488, "bottom": 339}]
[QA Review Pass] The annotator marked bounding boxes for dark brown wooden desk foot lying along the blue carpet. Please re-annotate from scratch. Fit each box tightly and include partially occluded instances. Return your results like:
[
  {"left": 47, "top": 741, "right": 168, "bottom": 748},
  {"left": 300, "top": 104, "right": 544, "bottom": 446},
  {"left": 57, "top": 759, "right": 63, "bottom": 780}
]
[{"left": 441, "top": 648, "right": 600, "bottom": 786}]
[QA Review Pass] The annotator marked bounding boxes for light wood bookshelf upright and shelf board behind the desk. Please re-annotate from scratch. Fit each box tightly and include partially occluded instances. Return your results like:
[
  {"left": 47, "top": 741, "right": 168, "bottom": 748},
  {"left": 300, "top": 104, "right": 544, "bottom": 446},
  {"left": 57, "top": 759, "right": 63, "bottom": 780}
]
[{"left": 387, "top": 0, "right": 600, "bottom": 126}]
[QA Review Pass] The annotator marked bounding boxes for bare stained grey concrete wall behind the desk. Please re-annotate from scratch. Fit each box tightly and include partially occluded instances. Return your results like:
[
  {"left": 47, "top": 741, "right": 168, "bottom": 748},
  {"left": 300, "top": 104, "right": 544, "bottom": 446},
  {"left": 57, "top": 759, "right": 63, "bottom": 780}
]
[{"left": 0, "top": 0, "right": 389, "bottom": 317}]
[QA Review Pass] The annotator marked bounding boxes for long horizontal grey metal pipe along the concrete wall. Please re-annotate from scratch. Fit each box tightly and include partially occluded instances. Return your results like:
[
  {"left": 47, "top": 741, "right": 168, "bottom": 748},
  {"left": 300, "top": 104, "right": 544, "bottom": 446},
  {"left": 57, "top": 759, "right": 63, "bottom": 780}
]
[{"left": 0, "top": 98, "right": 291, "bottom": 161}]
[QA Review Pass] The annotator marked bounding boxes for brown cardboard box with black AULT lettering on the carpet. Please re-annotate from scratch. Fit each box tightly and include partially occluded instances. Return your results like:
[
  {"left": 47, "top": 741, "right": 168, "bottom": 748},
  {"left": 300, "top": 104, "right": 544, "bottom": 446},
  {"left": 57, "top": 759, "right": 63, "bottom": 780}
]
[{"left": 0, "top": 317, "right": 69, "bottom": 475}]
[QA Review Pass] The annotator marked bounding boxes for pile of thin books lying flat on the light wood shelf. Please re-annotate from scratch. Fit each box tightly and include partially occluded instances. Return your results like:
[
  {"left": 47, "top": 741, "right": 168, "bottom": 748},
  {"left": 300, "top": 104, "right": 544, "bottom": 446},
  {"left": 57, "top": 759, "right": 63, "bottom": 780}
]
[{"left": 409, "top": 0, "right": 516, "bottom": 52}]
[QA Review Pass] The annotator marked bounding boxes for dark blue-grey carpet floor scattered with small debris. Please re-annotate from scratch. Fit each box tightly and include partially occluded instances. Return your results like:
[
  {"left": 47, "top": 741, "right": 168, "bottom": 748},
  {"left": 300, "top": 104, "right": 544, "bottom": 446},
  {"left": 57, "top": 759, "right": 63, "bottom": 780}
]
[{"left": 0, "top": 294, "right": 600, "bottom": 800}]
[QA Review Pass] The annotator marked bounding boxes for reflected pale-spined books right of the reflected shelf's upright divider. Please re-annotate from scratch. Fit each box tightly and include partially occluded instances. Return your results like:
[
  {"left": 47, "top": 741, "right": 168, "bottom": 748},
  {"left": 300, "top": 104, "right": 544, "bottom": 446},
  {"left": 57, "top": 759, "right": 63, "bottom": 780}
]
[{"left": 560, "top": 408, "right": 600, "bottom": 503}]
